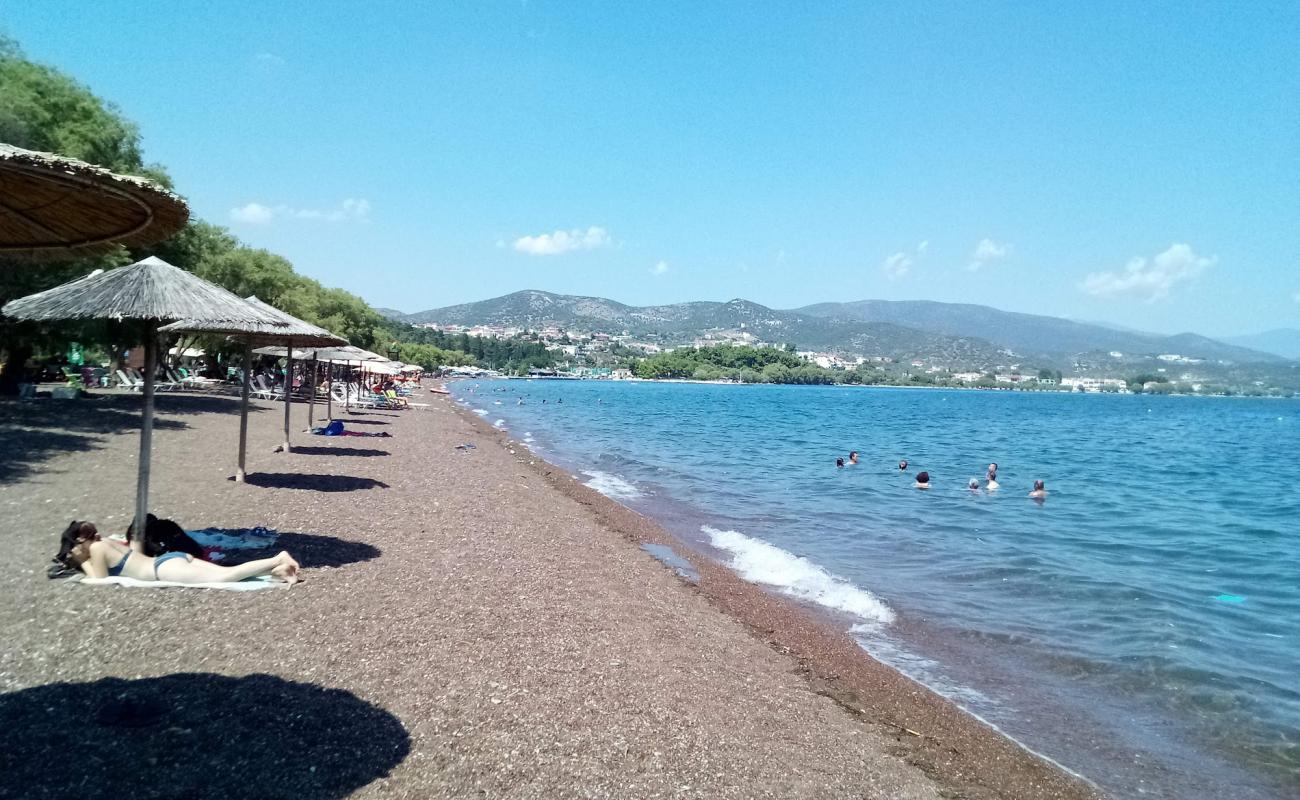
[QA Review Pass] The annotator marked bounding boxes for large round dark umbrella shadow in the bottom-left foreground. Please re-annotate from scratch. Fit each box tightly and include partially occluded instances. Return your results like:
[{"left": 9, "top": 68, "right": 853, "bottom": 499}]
[{"left": 0, "top": 673, "right": 411, "bottom": 800}]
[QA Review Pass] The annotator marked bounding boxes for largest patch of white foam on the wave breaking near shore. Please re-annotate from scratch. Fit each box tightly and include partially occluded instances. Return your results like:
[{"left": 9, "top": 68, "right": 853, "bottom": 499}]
[{"left": 699, "top": 526, "right": 894, "bottom": 624}]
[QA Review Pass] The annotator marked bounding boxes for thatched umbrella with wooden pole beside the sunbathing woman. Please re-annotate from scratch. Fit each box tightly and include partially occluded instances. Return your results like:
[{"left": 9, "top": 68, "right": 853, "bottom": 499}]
[{"left": 0, "top": 256, "right": 282, "bottom": 531}]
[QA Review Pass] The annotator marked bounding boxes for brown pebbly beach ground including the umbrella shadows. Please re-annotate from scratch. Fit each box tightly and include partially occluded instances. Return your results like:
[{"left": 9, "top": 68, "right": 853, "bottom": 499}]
[{"left": 0, "top": 394, "right": 1095, "bottom": 799}]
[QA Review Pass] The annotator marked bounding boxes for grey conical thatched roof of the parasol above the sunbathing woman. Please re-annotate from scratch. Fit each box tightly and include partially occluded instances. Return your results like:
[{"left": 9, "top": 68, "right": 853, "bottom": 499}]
[{"left": 3, "top": 256, "right": 285, "bottom": 325}]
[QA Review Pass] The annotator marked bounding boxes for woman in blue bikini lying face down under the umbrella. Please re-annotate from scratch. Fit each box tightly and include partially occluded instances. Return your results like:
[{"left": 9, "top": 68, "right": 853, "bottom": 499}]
[{"left": 55, "top": 516, "right": 298, "bottom": 584}]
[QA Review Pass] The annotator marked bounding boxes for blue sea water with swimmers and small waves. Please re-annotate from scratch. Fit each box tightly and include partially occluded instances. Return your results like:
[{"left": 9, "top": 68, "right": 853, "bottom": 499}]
[{"left": 452, "top": 381, "right": 1300, "bottom": 797}]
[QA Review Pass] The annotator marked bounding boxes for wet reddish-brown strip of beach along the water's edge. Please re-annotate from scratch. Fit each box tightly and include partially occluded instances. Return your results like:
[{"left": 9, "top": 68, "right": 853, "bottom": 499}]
[{"left": 445, "top": 395, "right": 1106, "bottom": 800}]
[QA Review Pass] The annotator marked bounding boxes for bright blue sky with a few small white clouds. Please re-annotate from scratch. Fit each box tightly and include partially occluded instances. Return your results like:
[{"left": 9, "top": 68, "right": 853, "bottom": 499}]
[{"left": 0, "top": 0, "right": 1300, "bottom": 336}]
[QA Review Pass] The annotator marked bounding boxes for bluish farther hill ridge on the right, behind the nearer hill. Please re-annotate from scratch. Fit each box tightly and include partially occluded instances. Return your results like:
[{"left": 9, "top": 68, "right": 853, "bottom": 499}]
[{"left": 797, "top": 300, "right": 1279, "bottom": 363}]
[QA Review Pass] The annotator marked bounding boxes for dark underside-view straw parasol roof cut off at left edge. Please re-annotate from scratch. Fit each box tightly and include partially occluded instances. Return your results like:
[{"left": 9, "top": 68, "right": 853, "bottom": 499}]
[{"left": 0, "top": 143, "right": 190, "bottom": 260}]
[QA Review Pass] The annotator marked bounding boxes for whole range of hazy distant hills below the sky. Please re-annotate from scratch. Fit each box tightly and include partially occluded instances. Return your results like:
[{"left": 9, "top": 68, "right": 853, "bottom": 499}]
[{"left": 395, "top": 290, "right": 1283, "bottom": 368}]
